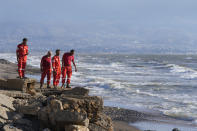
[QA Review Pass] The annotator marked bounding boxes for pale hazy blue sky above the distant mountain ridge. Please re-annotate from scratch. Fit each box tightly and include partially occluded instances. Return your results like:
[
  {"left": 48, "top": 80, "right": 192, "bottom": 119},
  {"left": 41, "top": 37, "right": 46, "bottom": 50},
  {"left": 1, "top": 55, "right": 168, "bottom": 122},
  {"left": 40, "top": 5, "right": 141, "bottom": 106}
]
[{"left": 0, "top": 0, "right": 197, "bottom": 25}]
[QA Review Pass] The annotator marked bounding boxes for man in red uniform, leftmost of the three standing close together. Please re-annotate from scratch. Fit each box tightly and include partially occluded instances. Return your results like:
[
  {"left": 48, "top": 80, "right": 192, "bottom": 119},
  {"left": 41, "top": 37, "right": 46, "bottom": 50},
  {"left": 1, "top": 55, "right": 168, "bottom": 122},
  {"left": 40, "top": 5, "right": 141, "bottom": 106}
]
[{"left": 40, "top": 51, "right": 52, "bottom": 88}]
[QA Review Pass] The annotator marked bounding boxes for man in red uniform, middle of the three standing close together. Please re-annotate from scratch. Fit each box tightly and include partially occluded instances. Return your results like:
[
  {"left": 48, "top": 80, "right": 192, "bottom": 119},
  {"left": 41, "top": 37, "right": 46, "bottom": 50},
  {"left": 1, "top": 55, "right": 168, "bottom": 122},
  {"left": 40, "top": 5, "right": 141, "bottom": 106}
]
[{"left": 52, "top": 49, "right": 61, "bottom": 88}]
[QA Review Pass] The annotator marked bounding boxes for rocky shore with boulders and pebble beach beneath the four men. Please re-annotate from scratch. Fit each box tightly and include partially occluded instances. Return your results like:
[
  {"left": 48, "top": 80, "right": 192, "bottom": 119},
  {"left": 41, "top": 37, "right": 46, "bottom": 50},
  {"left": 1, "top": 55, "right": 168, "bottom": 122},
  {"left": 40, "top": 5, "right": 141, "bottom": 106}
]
[{"left": 0, "top": 59, "right": 185, "bottom": 131}]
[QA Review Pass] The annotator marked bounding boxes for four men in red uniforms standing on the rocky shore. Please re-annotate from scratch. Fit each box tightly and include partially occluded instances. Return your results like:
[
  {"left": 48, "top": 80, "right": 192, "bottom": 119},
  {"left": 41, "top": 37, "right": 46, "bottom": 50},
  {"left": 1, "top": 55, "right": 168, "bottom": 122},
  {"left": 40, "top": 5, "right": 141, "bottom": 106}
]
[{"left": 16, "top": 38, "right": 77, "bottom": 88}]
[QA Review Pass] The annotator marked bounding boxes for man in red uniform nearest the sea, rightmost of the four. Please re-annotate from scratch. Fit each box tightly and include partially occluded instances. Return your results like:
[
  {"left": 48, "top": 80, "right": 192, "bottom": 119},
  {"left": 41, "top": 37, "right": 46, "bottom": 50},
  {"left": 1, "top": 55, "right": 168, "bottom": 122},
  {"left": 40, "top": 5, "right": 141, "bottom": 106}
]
[{"left": 62, "top": 50, "right": 77, "bottom": 88}]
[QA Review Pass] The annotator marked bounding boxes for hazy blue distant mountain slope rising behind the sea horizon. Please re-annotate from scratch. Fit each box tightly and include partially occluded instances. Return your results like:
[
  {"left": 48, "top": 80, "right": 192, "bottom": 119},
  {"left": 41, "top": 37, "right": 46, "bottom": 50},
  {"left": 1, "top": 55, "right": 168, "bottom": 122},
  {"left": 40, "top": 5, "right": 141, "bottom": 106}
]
[{"left": 0, "top": 22, "right": 197, "bottom": 53}]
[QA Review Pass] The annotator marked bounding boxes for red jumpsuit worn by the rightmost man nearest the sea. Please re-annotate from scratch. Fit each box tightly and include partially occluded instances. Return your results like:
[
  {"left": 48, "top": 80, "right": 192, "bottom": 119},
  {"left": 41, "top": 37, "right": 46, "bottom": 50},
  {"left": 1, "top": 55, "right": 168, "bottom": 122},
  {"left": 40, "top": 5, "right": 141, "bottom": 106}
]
[{"left": 62, "top": 53, "right": 74, "bottom": 84}]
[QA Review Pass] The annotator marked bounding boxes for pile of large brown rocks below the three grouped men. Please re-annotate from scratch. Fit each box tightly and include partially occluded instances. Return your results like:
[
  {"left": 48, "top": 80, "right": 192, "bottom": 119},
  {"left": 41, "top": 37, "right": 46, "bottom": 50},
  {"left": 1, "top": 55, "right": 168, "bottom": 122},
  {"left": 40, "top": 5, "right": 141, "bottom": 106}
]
[{"left": 13, "top": 87, "right": 113, "bottom": 131}]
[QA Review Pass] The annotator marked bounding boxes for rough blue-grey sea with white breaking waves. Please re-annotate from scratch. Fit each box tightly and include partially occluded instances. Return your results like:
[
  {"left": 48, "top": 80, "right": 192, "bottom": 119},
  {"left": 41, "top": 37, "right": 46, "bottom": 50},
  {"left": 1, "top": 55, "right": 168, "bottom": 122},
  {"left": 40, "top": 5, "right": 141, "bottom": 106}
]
[{"left": 0, "top": 53, "right": 197, "bottom": 129}]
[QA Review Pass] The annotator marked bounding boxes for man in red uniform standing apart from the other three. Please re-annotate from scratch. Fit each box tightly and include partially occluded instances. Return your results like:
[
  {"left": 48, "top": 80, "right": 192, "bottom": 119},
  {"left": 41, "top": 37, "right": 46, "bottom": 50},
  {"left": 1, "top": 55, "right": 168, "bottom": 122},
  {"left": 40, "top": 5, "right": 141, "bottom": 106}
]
[{"left": 16, "top": 38, "right": 28, "bottom": 79}]
